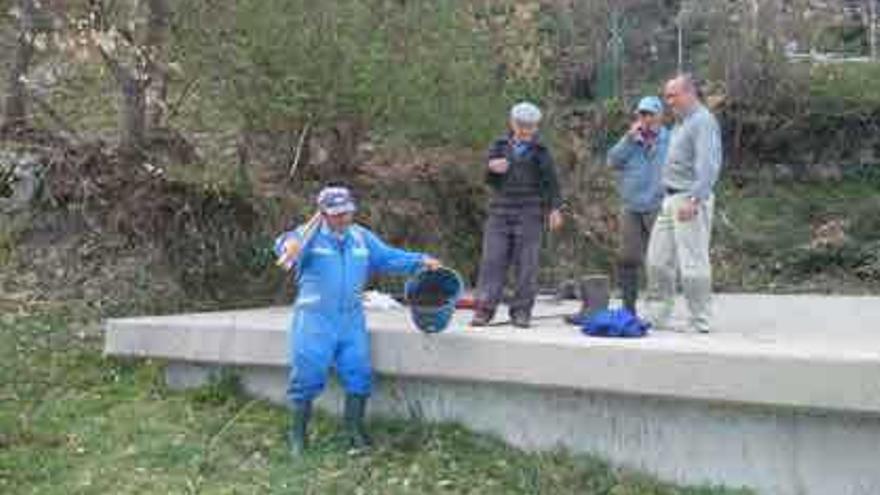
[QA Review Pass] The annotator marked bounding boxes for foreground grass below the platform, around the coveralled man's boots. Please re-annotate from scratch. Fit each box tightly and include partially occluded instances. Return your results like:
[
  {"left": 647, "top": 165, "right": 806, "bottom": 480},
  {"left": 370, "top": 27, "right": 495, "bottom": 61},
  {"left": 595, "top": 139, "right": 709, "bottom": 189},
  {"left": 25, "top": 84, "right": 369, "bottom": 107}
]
[{"left": 0, "top": 308, "right": 741, "bottom": 495}]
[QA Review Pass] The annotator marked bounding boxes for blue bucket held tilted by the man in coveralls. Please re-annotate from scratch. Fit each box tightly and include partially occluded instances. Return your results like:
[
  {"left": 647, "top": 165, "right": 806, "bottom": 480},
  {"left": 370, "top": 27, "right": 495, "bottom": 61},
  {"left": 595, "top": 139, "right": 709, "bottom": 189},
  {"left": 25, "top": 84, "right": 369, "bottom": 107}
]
[{"left": 403, "top": 268, "right": 464, "bottom": 333}]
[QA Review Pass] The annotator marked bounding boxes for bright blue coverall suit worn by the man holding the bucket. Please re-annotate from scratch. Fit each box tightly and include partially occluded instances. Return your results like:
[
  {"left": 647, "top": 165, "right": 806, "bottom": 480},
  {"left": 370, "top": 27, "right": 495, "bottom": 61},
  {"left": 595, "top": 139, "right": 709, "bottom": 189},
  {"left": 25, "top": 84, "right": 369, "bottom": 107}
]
[{"left": 275, "top": 225, "right": 426, "bottom": 404}]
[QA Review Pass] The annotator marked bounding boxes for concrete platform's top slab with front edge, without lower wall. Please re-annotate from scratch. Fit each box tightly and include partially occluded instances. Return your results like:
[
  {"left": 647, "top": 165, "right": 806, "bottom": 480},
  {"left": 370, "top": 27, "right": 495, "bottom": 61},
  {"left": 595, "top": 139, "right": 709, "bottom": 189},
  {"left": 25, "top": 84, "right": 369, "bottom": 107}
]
[{"left": 106, "top": 296, "right": 880, "bottom": 413}]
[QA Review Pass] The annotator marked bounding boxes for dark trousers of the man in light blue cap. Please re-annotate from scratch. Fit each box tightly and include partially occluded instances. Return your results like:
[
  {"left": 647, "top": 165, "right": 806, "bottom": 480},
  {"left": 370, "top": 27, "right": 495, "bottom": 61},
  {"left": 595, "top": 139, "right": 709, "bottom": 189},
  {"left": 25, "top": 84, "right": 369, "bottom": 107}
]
[{"left": 618, "top": 210, "right": 657, "bottom": 312}]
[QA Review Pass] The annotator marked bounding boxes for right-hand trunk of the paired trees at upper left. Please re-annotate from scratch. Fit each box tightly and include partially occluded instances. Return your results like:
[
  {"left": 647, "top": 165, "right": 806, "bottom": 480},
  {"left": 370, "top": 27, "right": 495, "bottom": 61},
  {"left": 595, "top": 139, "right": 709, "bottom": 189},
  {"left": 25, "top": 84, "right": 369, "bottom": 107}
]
[{"left": 144, "top": 0, "right": 170, "bottom": 130}]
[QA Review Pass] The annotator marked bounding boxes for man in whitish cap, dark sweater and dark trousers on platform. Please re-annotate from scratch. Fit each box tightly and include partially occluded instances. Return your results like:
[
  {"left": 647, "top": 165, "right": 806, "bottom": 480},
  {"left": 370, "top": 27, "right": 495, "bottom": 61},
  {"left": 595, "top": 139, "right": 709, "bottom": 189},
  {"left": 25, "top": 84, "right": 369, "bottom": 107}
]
[{"left": 471, "top": 102, "right": 562, "bottom": 328}]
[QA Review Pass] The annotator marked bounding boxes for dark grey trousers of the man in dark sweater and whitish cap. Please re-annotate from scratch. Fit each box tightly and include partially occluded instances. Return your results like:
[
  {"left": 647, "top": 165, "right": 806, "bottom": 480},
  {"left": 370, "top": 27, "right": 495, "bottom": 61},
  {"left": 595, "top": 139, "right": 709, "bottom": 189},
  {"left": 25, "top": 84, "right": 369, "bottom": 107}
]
[{"left": 477, "top": 206, "right": 544, "bottom": 316}]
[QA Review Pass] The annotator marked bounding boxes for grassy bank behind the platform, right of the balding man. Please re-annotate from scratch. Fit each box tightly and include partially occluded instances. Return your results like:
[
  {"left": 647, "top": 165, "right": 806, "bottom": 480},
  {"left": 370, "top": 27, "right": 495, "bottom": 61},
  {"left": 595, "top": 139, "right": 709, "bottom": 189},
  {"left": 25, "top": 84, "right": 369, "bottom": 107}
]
[{"left": 712, "top": 176, "right": 880, "bottom": 293}]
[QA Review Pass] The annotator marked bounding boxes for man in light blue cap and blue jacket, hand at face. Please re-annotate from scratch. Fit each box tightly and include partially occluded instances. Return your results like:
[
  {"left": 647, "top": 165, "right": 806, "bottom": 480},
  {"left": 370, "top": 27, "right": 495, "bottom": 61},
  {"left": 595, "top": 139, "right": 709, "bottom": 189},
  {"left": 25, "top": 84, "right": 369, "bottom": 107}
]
[{"left": 608, "top": 96, "right": 669, "bottom": 314}]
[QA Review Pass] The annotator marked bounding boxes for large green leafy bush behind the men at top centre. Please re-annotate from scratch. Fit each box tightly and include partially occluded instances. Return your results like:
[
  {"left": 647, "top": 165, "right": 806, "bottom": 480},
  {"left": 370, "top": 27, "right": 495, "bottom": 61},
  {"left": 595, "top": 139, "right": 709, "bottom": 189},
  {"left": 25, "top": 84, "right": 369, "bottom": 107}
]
[{"left": 176, "top": 0, "right": 521, "bottom": 144}]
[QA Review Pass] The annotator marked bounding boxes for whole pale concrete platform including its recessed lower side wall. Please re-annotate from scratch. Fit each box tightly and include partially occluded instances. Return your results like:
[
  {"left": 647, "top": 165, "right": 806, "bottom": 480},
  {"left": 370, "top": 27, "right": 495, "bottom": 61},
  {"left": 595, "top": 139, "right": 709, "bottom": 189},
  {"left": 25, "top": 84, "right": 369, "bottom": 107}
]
[{"left": 106, "top": 295, "right": 880, "bottom": 495}]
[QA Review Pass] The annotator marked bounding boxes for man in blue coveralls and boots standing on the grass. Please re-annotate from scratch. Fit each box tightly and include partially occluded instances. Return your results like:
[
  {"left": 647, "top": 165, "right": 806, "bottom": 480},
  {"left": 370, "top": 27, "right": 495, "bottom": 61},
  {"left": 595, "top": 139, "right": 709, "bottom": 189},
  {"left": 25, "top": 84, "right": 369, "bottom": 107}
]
[{"left": 275, "top": 187, "right": 440, "bottom": 456}]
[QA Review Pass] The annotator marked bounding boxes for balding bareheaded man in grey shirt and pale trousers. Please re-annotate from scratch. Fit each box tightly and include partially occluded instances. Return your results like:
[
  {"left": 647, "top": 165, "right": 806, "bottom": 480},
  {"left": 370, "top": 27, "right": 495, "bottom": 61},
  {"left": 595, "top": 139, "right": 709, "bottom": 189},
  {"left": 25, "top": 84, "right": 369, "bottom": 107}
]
[{"left": 647, "top": 75, "right": 722, "bottom": 333}]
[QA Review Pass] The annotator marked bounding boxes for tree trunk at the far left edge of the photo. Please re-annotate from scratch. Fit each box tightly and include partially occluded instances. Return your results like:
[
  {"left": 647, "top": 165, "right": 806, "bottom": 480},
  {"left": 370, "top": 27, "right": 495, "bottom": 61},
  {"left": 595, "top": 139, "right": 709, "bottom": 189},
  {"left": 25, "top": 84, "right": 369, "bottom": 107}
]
[{"left": 3, "top": 0, "right": 35, "bottom": 133}]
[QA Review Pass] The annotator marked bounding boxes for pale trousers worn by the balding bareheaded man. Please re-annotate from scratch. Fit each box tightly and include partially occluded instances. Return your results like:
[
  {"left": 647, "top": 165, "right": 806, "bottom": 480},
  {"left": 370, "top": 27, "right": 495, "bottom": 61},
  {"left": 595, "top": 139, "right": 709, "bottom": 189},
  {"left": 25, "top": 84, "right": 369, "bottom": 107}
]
[{"left": 646, "top": 194, "right": 715, "bottom": 332}]
